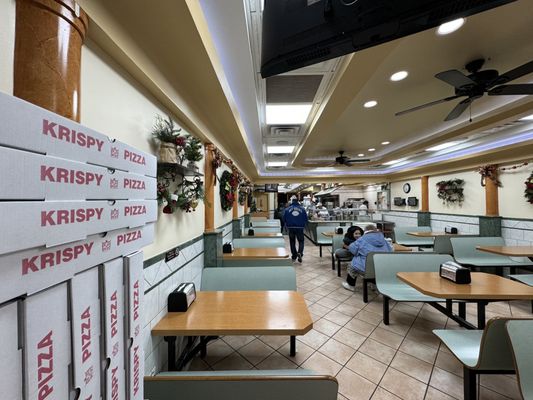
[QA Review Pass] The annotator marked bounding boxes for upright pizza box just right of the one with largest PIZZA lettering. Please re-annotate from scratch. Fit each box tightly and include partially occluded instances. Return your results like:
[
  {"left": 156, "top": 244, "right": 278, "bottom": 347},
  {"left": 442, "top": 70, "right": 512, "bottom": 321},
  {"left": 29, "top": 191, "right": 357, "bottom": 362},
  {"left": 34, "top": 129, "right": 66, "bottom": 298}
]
[{"left": 70, "top": 267, "right": 102, "bottom": 400}]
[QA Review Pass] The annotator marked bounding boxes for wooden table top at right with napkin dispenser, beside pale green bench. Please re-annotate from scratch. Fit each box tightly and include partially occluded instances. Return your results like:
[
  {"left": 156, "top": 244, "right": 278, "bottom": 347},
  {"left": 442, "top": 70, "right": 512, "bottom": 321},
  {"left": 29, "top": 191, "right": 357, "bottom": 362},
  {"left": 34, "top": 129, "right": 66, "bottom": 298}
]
[{"left": 397, "top": 272, "right": 533, "bottom": 300}]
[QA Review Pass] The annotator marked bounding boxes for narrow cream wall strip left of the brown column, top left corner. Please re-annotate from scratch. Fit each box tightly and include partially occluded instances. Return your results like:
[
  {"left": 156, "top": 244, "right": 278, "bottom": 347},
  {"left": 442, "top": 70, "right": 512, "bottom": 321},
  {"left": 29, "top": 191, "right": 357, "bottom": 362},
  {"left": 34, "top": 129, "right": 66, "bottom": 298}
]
[{"left": 0, "top": 0, "right": 15, "bottom": 94}]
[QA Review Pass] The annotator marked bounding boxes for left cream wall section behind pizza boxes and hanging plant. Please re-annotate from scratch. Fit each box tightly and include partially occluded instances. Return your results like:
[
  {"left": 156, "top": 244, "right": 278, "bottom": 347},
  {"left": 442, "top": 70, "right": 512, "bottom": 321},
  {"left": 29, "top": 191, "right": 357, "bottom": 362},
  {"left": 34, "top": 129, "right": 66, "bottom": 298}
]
[{"left": 81, "top": 43, "right": 204, "bottom": 258}]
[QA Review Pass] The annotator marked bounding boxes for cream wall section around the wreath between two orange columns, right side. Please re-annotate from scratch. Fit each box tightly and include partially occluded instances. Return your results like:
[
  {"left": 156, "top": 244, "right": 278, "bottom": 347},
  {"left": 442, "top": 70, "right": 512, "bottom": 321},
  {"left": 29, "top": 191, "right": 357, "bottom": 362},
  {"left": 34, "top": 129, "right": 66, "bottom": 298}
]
[{"left": 428, "top": 171, "right": 484, "bottom": 217}]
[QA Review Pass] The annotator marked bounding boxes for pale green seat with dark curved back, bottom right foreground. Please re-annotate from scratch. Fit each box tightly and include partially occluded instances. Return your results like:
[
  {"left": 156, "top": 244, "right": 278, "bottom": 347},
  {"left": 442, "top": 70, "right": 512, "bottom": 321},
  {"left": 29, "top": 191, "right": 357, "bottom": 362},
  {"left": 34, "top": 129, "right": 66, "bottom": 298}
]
[{"left": 433, "top": 318, "right": 515, "bottom": 400}]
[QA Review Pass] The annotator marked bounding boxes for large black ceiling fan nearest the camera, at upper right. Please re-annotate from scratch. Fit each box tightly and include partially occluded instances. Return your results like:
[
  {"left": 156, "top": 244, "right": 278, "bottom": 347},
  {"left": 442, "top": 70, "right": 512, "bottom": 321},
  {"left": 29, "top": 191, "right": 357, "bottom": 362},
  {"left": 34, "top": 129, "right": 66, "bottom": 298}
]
[{"left": 395, "top": 59, "right": 533, "bottom": 121}]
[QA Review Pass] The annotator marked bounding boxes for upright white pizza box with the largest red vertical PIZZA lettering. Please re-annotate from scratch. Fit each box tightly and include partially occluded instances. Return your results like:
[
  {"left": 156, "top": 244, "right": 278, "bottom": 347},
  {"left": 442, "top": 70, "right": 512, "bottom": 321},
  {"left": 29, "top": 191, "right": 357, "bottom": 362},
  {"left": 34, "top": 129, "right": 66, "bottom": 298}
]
[{"left": 22, "top": 283, "right": 70, "bottom": 400}]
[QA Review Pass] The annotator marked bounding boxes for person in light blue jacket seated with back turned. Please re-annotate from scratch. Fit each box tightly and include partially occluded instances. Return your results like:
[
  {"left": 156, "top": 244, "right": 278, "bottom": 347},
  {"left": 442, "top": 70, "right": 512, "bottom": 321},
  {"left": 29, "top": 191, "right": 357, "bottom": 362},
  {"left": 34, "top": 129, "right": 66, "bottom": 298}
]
[{"left": 342, "top": 224, "right": 392, "bottom": 292}]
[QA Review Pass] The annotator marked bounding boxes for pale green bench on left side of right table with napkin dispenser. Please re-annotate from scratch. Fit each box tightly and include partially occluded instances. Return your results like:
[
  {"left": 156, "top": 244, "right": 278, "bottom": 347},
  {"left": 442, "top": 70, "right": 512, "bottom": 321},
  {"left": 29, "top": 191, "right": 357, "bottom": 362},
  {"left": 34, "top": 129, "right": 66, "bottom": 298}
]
[{"left": 372, "top": 253, "right": 453, "bottom": 325}]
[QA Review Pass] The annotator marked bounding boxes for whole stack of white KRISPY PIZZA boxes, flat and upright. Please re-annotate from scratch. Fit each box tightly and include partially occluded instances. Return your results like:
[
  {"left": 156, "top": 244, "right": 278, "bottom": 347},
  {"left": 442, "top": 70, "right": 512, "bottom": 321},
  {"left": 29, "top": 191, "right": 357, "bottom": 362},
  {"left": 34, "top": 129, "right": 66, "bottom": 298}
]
[{"left": 0, "top": 93, "right": 157, "bottom": 400}]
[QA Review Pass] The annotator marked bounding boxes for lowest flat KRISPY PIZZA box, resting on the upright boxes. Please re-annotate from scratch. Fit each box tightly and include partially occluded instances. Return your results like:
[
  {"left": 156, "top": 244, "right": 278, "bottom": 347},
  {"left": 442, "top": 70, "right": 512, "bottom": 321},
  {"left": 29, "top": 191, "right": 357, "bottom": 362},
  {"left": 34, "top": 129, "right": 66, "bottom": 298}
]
[{"left": 0, "top": 224, "right": 155, "bottom": 303}]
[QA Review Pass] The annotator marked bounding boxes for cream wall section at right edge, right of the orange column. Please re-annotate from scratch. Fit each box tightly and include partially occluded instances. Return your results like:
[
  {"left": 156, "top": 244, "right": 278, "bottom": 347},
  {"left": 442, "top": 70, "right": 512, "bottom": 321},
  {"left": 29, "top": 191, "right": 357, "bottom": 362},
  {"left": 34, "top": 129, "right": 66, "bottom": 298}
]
[{"left": 499, "top": 166, "right": 533, "bottom": 219}]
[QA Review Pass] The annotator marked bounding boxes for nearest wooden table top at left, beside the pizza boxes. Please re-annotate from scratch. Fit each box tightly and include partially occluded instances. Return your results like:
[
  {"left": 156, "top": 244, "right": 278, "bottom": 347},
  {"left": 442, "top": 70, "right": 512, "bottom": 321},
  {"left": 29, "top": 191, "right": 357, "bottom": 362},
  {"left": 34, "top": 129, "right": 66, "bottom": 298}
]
[{"left": 152, "top": 291, "right": 313, "bottom": 336}]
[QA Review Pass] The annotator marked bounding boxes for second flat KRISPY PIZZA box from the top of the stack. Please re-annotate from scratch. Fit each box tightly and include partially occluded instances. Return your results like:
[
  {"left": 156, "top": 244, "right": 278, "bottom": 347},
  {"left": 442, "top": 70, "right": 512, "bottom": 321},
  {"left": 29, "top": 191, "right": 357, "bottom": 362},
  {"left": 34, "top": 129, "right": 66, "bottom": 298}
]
[{"left": 0, "top": 147, "right": 157, "bottom": 200}]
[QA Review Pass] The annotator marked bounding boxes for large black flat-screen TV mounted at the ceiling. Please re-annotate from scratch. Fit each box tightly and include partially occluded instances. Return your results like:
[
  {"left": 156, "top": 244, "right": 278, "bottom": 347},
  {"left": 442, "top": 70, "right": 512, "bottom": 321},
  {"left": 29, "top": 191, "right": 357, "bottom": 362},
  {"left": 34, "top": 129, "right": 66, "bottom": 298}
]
[{"left": 261, "top": 0, "right": 516, "bottom": 78}]
